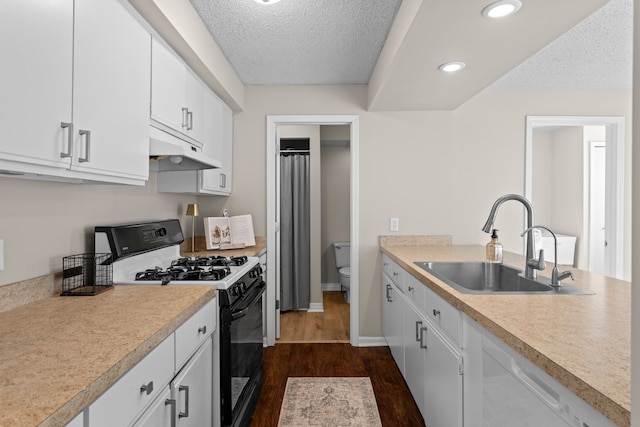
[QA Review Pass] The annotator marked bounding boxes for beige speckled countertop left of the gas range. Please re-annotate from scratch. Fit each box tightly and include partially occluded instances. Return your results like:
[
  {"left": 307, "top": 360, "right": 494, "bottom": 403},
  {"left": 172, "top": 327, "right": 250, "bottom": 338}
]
[{"left": 0, "top": 286, "right": 216, "bottom": 427}]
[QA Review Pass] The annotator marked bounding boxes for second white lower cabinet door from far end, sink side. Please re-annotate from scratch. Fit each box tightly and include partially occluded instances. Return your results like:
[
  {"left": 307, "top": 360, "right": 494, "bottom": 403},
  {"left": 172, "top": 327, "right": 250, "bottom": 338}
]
[{"left": 403, "top": 308, "right": 428, "bottom": 418}]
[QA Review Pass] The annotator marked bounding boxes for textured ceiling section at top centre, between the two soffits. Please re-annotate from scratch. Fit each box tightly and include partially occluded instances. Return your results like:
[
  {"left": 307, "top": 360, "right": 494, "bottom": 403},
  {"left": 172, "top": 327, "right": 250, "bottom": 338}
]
[{"left": 190, "top": 0, "right": 400, "bottom": 84}]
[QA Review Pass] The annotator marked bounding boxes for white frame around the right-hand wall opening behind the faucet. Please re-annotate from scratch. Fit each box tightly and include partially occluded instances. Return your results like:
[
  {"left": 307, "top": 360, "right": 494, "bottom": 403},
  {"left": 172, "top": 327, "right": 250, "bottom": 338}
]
[{"left": 524, "top": 116, "right": 625, "bottom": 278}]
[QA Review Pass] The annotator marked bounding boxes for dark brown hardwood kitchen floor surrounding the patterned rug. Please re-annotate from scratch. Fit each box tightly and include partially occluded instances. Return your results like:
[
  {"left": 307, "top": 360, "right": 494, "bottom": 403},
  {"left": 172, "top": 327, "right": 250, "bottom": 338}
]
[{"left": 251, "top": 343, "right": 424, "bottom": 427}]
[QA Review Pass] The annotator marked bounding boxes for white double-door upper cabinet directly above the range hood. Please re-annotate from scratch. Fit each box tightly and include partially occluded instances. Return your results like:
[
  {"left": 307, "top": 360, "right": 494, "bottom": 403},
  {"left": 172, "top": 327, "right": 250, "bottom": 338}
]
[{"left": 151, "top": 38, "right": 205, "bottom": 147}]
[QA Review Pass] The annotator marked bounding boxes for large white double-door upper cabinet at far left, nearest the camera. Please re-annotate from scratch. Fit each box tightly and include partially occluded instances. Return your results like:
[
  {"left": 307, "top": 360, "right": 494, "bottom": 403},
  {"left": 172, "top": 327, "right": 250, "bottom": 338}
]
[{"left": 0, "top": 0, "right": 150, "bottom": 185}]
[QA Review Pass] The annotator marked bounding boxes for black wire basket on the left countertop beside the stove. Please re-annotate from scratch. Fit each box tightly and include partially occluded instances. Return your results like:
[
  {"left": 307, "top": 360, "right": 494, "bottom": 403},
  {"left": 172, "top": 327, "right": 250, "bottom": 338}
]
[{"left": 61, "top": 254, "right": 113, "bottom": 295}]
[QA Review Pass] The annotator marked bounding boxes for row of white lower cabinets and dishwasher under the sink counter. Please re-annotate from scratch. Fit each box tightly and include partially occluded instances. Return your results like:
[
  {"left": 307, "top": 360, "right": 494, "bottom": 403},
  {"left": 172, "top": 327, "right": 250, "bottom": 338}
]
[{"left": 382, "top": 255, "right": 614, "bottom": 427}]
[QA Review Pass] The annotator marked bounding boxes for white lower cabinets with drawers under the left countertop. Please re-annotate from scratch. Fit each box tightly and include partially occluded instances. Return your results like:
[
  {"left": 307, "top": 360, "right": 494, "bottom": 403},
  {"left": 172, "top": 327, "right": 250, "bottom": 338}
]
[{"left": 86, "top": 298, "right": 217, "bottom": 427}]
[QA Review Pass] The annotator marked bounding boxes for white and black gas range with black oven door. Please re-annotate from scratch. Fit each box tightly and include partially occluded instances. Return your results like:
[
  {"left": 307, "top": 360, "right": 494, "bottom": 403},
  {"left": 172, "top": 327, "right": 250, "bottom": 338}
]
[{"left": 95, "top": 219, "right": 266, "bottom": 427}]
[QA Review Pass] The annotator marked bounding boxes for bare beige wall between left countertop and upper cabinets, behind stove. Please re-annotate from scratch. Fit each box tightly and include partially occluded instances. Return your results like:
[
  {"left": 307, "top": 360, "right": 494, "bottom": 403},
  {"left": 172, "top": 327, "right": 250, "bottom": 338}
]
[{"left": 0, "top": 172, "right": 195, "bottom": 285}]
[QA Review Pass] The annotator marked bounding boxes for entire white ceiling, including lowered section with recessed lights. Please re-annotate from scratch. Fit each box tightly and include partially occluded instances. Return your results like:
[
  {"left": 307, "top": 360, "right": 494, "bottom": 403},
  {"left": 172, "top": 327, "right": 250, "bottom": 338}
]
[{"left": 189, "top": 0, "right": 633, "bottom": 111}]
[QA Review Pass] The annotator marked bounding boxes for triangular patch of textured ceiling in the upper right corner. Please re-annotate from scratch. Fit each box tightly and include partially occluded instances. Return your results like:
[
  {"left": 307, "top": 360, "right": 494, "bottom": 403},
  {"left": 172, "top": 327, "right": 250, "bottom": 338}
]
[{"left": 491, "top": 0, "right": 633, "bottom": 89}]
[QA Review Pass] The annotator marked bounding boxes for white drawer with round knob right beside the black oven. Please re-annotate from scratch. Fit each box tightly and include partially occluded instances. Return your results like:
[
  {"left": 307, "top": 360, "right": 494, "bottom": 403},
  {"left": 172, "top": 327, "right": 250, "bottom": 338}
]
[{"left": 176, "top": 297, "right": 218, "bottom": 369}]
